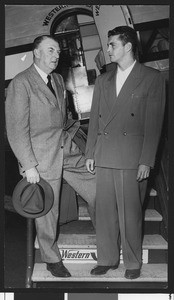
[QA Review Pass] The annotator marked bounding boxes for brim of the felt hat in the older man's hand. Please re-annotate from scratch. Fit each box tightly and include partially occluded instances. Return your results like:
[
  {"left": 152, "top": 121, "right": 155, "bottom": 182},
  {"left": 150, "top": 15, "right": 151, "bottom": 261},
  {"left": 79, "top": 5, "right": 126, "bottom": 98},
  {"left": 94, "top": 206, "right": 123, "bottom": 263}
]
[{"left": 12, "top": 177, "right": 54, "bottom": 219}]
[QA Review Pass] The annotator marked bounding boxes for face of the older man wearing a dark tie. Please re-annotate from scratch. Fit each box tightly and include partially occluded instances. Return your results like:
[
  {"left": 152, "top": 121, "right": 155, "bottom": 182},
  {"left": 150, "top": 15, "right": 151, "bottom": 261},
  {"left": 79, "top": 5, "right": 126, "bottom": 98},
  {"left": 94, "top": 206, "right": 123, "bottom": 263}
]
[{"left": 35, "top": 38, "right": 60, "bottom": 74}]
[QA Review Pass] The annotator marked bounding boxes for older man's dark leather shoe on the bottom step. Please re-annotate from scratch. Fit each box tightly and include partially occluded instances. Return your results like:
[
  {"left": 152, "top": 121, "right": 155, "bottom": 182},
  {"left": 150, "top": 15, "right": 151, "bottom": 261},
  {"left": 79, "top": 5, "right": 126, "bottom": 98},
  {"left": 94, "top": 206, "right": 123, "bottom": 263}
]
[{"left": 47, "top": 261, "right": 71, "bottom": 277}]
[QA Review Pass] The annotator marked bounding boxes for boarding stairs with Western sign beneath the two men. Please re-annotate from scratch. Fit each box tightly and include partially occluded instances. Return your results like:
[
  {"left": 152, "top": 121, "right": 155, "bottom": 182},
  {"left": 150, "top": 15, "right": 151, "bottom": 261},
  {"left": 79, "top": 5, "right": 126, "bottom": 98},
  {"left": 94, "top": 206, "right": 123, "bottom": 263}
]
[{"left": 29, "top": 188, "right": 168, "bottom": 289}]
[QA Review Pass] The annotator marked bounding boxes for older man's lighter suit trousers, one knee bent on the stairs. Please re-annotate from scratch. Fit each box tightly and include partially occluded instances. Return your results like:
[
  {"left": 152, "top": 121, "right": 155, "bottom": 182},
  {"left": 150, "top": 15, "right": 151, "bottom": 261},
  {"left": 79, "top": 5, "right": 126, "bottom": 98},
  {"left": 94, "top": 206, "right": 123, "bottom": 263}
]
[{"left": 35, "top": 142, "right": 96, "bottom": 263}]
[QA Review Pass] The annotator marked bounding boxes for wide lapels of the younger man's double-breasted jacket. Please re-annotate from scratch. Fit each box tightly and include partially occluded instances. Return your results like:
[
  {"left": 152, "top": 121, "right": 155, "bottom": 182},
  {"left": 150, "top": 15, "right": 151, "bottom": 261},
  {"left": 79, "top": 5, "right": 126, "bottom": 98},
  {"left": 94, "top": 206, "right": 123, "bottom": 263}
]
[{"left": 104, "top": 62, "right": 142, "bottom": 125}]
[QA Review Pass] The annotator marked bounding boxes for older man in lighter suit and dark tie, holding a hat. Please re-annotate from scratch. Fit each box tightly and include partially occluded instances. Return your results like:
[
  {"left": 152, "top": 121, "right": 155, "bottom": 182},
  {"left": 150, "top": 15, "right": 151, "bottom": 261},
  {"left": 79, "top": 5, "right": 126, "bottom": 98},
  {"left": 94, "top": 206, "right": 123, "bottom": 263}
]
[{"left": 6, "top": 35, "right": 95, "bottom": 277}]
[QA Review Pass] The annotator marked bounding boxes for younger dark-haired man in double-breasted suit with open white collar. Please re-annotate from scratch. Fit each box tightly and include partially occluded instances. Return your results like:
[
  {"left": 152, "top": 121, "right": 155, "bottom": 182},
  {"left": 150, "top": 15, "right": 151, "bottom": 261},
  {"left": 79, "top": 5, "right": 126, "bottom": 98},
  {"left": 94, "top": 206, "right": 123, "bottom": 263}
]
[{"left": 86, "top": 26, "right": 165, "bottom": 279}]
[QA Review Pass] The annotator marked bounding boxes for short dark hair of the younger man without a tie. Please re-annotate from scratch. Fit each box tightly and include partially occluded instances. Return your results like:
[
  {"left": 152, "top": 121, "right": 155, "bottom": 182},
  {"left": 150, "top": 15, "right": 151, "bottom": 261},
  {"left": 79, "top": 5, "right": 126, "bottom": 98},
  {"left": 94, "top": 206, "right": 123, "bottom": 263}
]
[{"left": 108, "top": 26, "right": 138, "bottom": 55}]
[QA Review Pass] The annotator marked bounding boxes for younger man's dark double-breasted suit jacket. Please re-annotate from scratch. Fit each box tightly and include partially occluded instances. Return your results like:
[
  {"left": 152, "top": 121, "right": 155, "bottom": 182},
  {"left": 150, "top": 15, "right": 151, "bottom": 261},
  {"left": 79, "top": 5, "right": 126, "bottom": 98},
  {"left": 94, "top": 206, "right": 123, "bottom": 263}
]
[{"left": 86, "top": 62, "right": 165, "bottom": 169}]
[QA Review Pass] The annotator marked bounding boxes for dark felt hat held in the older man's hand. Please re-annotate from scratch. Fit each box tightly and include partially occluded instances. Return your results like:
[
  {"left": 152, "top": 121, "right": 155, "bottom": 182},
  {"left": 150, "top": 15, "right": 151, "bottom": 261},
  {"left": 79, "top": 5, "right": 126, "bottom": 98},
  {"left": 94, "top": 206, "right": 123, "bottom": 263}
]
[{"left": 12, "top": 177, "right": 54, "bottom": 218}]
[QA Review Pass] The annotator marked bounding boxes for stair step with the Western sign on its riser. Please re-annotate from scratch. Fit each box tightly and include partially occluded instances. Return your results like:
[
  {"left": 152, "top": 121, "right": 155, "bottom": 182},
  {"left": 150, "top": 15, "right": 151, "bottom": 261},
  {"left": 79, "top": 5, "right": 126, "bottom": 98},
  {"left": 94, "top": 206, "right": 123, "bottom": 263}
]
[{"left": 35, "top": 234, "right": 167, "bottom": 264}]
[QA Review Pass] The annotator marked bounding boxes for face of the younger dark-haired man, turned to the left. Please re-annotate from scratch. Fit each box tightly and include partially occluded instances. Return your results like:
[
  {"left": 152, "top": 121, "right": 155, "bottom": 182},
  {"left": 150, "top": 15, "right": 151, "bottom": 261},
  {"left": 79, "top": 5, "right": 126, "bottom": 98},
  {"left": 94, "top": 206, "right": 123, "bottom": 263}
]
[{"left": 107, "top": 35, "right": 127, "bottom": 63}]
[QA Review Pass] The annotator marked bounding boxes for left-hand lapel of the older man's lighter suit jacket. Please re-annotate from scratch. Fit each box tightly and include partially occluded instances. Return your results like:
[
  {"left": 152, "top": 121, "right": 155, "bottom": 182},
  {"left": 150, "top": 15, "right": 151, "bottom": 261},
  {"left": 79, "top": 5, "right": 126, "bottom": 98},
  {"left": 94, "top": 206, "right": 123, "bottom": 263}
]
[{"left": 30, "top": 65, "right": 58, "bottom": 106}]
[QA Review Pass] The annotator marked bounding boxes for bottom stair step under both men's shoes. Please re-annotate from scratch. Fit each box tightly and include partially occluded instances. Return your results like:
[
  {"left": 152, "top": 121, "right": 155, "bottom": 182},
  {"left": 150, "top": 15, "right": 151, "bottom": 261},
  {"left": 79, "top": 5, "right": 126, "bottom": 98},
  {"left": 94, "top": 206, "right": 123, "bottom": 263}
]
[{"left": 32, "top": 262, "right": 167, "bottom": 282}]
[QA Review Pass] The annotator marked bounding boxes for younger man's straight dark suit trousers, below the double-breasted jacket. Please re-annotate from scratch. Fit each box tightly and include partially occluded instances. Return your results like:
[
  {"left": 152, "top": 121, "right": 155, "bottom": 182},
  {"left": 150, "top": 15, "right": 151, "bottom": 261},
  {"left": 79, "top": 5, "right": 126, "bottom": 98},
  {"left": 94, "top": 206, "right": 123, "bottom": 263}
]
[{"left": 96, "top": 167, "right": 147, "bottom": 269}]
